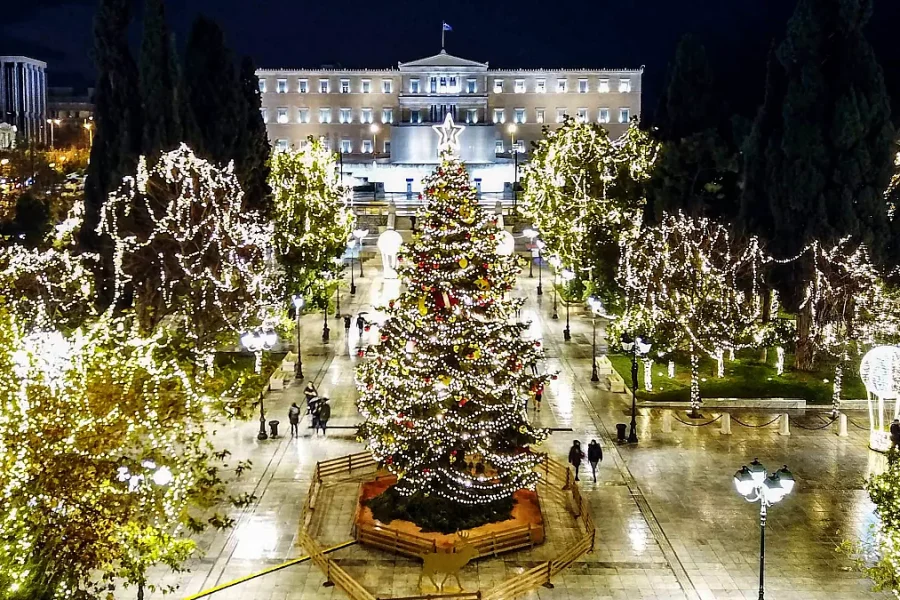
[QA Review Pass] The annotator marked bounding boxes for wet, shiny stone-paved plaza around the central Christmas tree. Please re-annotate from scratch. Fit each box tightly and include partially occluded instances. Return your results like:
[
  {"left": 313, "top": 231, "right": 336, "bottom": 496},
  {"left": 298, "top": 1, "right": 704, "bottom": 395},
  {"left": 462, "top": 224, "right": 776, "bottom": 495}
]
[{"left": 137, "top": 262, "right": 888, "bottom": 600}]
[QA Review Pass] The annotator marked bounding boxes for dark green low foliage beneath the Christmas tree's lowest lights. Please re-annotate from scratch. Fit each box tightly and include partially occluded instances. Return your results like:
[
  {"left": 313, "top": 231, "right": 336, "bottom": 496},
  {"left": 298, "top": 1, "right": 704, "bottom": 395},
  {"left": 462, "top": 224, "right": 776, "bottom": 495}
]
[{"left": 366, "top": 486, "right": 515, "bottom": 534}]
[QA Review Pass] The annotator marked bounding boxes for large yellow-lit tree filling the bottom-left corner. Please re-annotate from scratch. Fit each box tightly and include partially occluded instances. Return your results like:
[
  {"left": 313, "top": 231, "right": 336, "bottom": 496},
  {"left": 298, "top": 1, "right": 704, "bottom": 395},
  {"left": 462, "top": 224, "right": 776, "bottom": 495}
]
[{"left": 0, "top": 310, "right": 248, "bottom": 600}]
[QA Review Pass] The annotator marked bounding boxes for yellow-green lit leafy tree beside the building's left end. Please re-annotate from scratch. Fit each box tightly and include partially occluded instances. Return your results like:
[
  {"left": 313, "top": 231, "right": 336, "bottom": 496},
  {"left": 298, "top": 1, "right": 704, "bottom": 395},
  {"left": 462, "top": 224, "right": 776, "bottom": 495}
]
[{"left": 269, "top": 140, "right": 354, "bottom": 302}]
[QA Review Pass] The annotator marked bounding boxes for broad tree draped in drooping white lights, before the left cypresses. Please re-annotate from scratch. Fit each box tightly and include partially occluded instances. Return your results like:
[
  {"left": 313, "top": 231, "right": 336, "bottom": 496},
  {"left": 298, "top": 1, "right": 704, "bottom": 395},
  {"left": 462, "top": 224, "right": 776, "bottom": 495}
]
[{"left": 100, "top": 144, "right": 273, "bottom": 360}]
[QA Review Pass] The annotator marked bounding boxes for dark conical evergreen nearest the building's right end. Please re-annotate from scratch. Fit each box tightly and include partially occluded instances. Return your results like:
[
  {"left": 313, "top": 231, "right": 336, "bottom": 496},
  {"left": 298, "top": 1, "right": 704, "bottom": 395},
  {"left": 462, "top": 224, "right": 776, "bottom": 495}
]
[{"left": 648, "top": 35, "right": 738, "bottom": 221}]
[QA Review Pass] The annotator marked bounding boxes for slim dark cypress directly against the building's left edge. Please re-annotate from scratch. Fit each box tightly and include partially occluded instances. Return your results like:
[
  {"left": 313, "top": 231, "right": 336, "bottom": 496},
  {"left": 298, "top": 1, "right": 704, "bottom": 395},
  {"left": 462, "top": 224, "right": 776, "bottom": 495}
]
[{"left": 234, "top": 56, "right": 272, "bottom": 215}]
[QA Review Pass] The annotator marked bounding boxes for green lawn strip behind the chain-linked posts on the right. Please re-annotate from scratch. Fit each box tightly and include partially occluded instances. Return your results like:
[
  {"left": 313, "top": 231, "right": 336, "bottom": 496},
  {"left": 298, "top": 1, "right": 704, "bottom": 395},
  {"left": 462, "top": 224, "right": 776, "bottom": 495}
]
[{"left": 609, "top": 349, "right": 866, "bottom": 404}]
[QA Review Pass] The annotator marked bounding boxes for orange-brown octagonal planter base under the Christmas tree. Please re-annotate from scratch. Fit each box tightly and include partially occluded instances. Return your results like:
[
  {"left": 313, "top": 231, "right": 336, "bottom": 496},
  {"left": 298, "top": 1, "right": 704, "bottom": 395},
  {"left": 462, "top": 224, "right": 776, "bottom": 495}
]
[{"left": 354, "top": 477, "right": 544, "bottom": 558}]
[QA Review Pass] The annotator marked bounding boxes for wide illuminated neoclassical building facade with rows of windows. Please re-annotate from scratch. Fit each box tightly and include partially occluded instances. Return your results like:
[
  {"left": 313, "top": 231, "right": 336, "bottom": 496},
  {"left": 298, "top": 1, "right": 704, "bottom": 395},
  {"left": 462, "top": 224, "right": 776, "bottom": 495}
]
[{"left": 257, "top": 51, "right": 643, "bottom": 192}]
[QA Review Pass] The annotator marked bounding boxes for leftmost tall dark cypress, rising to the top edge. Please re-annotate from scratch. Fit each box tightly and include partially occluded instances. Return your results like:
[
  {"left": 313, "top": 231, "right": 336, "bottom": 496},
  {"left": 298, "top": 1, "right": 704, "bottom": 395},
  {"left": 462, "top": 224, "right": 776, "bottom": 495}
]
[{"left": 79, "top": 0, "right": 141, "bottom": 255}]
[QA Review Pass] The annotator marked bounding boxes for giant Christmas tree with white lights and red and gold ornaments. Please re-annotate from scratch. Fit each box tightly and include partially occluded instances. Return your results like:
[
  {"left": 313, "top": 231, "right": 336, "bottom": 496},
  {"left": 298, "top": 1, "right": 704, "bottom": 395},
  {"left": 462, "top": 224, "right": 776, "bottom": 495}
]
[{"left": 357, "top": 154, "right": 546, "bottom": 531}]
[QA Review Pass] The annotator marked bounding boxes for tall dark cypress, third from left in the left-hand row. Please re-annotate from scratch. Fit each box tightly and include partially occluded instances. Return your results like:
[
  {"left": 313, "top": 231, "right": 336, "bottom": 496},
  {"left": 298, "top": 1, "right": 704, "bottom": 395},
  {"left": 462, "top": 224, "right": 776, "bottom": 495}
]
[{"left": 184, "top": 16, "right": 246, "bottom": 166}]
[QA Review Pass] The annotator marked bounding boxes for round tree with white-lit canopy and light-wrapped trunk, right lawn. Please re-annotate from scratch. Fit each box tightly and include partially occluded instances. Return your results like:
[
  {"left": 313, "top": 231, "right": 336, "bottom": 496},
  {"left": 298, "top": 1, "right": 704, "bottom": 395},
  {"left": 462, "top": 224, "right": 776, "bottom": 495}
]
[{"left": 619, "top": 213, "right": 761, "bottom": 408}]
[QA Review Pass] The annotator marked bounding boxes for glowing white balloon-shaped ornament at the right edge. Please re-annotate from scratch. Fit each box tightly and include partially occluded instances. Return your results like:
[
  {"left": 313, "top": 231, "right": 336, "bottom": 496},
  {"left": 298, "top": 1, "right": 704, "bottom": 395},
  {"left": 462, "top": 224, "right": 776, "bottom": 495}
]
[{"left": 859, "top": 346, "right": 900, "bottom": 452}]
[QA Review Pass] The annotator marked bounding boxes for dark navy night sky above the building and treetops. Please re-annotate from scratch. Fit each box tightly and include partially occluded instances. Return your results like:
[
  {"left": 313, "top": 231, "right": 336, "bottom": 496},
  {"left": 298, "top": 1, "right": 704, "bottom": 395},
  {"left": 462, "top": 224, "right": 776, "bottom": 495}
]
[{"left": 0, "top": 0, "right": 900, "bottom": 117}]
